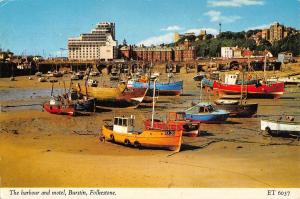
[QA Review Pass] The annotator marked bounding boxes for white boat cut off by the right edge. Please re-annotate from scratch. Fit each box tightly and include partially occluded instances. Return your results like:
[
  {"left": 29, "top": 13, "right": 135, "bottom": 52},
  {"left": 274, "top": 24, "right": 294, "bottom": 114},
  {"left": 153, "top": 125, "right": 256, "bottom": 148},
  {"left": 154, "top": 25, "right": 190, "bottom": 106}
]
[{"left": 260, "top": 116, "right": 300, "bottom": 137}]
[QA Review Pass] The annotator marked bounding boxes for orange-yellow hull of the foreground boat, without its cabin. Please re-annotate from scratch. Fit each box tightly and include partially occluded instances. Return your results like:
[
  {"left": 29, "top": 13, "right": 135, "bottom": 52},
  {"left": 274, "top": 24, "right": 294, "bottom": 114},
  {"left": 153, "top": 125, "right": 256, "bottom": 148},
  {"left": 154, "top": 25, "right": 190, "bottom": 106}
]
[{"left": 101, "top": 126, "right": 182, "bottom": 151}]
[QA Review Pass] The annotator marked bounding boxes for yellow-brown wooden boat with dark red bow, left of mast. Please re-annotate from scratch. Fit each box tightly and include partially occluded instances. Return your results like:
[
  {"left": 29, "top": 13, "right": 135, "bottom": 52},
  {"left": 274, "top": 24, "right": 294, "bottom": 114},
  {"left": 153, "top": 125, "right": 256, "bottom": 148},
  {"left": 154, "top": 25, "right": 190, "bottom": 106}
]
[{"left": 78, "top": 84, "right": 147, "bottom": 108}]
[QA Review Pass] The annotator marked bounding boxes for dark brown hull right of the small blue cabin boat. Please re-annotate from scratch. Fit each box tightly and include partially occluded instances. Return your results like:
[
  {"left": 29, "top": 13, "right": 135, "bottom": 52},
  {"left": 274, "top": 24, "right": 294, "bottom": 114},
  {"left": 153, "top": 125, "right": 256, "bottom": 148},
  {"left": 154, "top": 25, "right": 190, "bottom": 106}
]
[{"left": 215, "top": 104, "right": 258, "bottom": 117}]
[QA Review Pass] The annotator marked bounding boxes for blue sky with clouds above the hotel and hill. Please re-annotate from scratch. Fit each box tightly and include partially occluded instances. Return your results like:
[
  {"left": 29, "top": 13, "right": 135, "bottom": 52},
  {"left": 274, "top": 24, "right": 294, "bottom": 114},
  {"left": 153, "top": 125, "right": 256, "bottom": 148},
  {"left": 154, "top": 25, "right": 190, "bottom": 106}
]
[{"left": 0, "top": 0, "right": 300, "bottom": 57}]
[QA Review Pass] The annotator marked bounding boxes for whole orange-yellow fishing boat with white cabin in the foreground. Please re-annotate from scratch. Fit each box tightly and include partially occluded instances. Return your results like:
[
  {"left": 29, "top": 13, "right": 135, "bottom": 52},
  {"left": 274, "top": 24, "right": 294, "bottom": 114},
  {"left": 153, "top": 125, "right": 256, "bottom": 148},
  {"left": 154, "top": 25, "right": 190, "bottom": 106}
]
[{"left": 100, "top": 116, "right": 182, "bottom": 152}]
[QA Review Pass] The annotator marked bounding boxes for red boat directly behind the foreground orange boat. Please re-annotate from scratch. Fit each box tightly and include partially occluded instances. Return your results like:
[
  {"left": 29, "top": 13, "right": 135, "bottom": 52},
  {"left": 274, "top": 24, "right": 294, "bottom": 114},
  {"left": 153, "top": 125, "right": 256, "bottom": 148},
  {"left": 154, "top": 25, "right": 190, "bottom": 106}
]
[{"left": 144, "top": 112, "right": 200, "bottom": 137}]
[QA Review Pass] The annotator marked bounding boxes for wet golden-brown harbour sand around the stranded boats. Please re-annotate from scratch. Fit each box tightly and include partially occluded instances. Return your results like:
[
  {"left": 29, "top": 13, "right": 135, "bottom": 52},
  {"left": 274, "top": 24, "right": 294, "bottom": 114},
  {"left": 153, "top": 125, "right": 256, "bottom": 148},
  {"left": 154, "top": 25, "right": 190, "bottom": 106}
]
[{"left": 0, "top": 66, "right": 300, "bottom": 187}]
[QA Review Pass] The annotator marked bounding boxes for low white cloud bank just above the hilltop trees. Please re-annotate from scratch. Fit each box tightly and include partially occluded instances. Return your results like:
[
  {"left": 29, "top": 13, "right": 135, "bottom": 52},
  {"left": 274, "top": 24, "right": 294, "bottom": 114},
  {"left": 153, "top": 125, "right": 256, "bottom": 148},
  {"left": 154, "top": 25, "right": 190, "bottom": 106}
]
[{"left": 138, "top": 28, "right": 218, "bottom": 46}]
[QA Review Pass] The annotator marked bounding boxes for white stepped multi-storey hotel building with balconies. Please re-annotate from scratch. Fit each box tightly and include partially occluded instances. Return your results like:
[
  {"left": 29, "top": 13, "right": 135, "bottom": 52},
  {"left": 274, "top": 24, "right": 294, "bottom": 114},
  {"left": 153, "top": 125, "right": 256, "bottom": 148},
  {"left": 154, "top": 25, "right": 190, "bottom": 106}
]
[{"left": 68, "top": 22, "right": 117, "bottom": 61}]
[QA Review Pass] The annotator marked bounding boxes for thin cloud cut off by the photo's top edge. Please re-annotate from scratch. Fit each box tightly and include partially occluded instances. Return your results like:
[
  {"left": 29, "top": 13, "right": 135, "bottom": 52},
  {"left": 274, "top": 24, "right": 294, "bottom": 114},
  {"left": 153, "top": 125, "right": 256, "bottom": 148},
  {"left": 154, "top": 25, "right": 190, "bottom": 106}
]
[{"left": 207, "top": 0, "right": 264, "bottom": 7}]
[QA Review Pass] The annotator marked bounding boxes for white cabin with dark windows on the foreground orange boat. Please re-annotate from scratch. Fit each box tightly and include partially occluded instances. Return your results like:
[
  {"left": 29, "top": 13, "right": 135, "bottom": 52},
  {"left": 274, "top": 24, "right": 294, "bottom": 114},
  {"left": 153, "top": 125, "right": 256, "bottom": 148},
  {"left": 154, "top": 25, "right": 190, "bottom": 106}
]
[{"left": 113, "top": 115, "right": 135, "bottom": 133}]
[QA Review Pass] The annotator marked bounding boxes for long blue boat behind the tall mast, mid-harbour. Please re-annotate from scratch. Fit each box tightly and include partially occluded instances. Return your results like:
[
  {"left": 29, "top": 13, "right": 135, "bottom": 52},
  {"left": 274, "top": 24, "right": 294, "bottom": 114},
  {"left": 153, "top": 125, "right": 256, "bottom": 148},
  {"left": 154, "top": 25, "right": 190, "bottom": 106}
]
[{"left": 128, "top": 81, "right": 183, "bottom": 95}]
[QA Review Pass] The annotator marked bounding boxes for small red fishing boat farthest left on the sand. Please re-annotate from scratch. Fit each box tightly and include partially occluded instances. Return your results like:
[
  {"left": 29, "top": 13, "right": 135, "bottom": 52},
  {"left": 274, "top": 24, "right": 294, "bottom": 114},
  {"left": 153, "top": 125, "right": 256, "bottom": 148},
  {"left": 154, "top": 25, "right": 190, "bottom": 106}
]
[{"left": 43, "top": 96, "right": 76, "bottom": 116}]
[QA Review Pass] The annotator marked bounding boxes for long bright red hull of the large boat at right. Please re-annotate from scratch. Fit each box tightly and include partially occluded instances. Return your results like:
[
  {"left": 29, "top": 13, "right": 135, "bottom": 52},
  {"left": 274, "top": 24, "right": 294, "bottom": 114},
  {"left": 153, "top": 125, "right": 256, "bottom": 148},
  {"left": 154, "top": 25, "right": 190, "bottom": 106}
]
[{"left": 213, "top": 81, "right": 284, "bottom": 98}]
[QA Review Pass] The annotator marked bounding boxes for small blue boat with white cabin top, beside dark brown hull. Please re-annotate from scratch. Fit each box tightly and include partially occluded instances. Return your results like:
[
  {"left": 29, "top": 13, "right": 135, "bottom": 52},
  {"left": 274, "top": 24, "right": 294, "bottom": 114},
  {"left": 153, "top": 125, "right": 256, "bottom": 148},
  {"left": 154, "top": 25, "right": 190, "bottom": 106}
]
[{"left": 184, "top": 102, "right": 229, "bottom": 123}]
